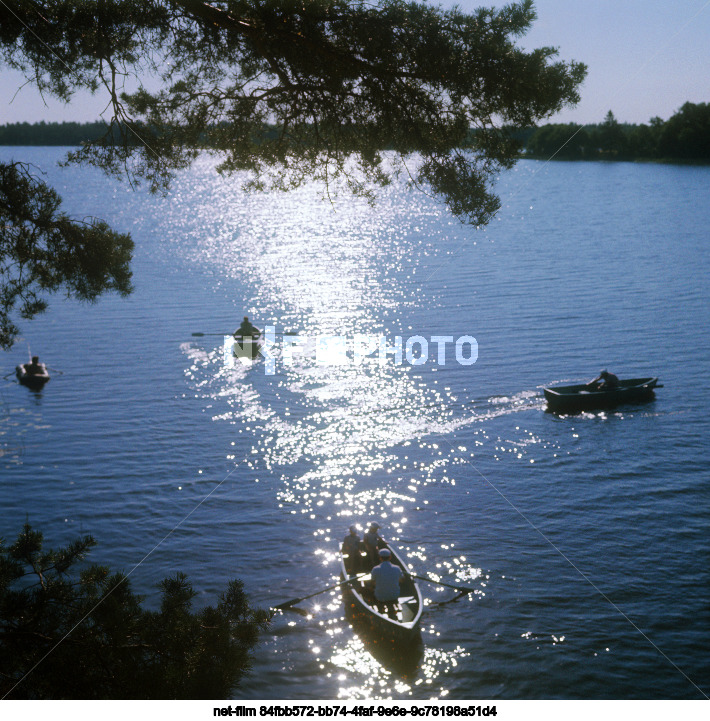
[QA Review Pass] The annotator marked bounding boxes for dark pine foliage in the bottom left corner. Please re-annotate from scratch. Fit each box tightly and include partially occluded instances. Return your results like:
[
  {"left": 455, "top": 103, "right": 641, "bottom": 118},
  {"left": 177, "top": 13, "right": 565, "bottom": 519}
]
[{"left": 0, "top": 524, "right": 268, "bottom": 699}]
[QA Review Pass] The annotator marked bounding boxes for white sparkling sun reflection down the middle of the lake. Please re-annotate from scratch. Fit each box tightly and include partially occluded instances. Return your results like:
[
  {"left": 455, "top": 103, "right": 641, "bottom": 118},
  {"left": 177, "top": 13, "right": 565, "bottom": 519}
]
[{"left": 168, "top": 160, "right": 490, "bottom": 698}]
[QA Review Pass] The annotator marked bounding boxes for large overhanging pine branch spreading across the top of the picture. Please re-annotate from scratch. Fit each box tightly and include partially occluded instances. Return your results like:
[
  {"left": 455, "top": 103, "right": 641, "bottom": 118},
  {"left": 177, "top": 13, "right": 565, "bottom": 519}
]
[{"left": 0, "top": 0, "right": 586, "bottom": 347}]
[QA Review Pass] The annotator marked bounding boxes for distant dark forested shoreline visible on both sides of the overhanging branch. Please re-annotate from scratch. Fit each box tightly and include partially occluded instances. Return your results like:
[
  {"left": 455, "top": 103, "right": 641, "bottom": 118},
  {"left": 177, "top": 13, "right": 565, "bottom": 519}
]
[{"left": 0, "top": 103, "right": 710, "bottom": 162}]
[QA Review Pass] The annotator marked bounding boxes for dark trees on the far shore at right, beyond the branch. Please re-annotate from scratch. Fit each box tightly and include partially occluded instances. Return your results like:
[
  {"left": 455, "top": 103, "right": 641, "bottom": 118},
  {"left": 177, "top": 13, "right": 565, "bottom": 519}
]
[{"left": 521, "top": 103, "right": 710, "bottom": 162}]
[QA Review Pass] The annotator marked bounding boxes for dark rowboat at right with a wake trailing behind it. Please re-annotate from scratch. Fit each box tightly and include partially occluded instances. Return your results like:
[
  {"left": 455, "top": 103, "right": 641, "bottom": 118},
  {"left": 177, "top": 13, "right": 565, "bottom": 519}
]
[{"left": 543, "top": 378, "right": 658, "bottom": 413}]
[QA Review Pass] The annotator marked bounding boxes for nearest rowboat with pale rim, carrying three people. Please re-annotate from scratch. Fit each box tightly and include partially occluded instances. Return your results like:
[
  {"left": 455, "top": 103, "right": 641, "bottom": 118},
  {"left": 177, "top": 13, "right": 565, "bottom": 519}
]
[{"left": 340, "top": 544, "right": 423, "bottom": 645}]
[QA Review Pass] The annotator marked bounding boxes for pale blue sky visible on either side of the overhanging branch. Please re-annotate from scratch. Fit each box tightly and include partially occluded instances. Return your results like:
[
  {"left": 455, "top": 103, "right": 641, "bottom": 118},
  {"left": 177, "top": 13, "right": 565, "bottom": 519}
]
[{"left": 0, "top": 0, "right": 710, "bottom": 124}]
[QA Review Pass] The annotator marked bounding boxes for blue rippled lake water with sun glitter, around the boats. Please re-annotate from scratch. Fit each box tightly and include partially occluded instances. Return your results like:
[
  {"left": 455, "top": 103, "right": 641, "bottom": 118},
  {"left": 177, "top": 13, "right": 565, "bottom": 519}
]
[{"left": 0, "top": 148, "right": 710, "bottom": 700}]
